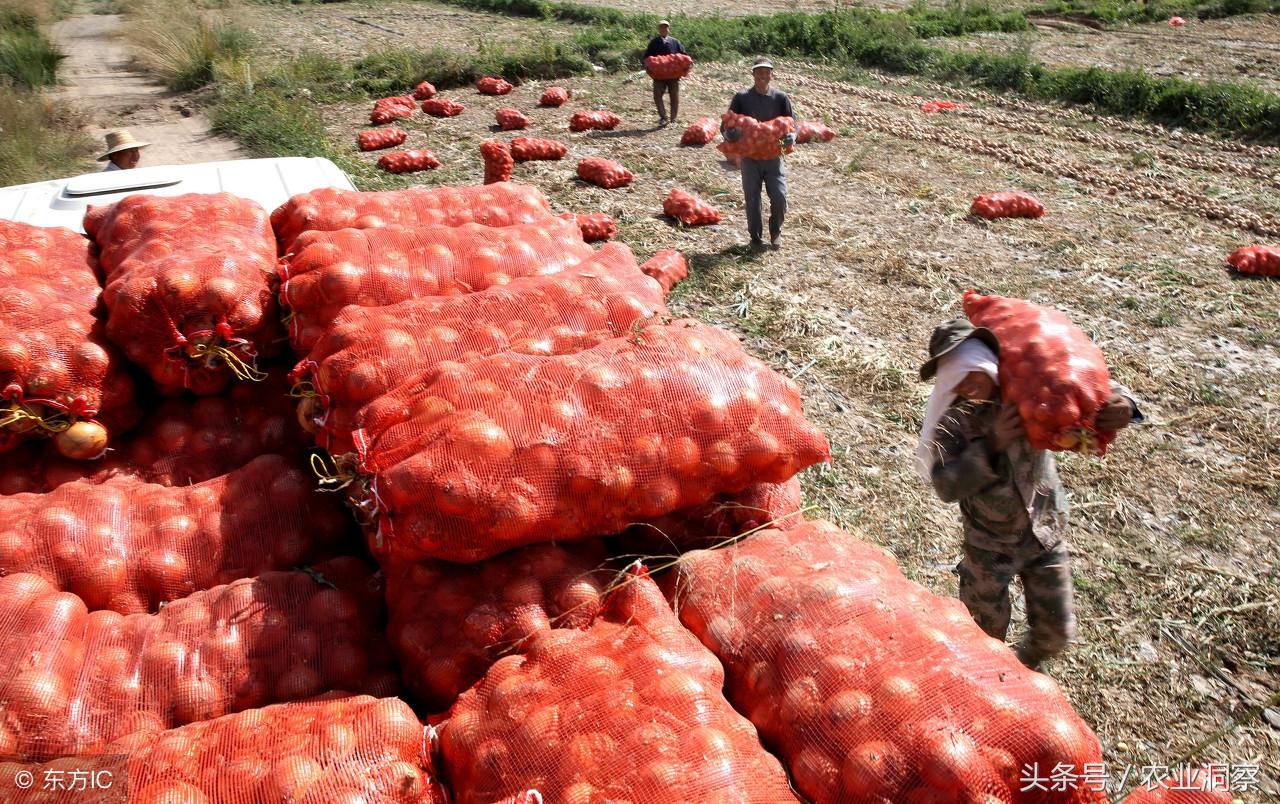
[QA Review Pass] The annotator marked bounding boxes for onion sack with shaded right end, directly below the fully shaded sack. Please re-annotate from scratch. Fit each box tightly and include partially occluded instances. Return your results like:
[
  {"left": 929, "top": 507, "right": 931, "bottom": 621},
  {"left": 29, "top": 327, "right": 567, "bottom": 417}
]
[{"left": 0, "top": 456, "right": 349, "bottom": 615}]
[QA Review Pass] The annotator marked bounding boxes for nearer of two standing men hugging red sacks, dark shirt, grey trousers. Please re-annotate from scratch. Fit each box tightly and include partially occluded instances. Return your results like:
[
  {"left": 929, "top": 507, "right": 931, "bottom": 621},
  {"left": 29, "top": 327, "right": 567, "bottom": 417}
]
[{"left": 721, "top": 59, "right": 796, "bottom": 248}]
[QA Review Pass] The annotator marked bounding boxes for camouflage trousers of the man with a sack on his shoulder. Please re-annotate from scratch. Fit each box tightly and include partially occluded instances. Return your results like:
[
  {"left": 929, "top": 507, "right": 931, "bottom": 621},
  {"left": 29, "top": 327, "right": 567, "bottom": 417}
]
[{"left": 956, "top": 533, "right": 1075, "bottom": 670}]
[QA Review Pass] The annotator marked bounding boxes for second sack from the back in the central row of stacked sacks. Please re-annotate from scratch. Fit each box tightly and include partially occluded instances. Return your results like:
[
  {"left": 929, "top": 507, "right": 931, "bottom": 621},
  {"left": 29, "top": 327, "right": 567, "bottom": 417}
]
[{"left": 280, "top": 218, "right": 593, "bottom": 353}]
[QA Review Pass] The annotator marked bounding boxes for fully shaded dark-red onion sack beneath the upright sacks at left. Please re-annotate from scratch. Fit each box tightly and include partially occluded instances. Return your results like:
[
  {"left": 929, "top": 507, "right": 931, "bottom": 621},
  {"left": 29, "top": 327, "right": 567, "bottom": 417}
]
[{"left": 0, "top": 370, "right": 311, "bottom": 494}]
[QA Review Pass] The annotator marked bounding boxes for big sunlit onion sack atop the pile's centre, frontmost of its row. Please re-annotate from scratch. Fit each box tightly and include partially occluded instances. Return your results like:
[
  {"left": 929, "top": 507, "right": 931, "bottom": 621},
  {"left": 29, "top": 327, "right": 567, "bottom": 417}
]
[{"left": 348, "top": 321, "right": 829, "bottom": 561}]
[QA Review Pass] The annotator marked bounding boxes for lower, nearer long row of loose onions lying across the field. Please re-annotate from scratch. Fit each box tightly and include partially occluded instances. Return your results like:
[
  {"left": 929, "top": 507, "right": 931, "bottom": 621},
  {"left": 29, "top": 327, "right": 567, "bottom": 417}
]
[{"left": 694, "top": 73, "right": 1280, "bottom": 237}]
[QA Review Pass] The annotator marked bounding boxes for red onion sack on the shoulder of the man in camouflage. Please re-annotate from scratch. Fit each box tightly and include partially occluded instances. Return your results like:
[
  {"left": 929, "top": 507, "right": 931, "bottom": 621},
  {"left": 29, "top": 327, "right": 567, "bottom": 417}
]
[{"left": 964, "top": 291, "right": 1115, "bottom": 454}]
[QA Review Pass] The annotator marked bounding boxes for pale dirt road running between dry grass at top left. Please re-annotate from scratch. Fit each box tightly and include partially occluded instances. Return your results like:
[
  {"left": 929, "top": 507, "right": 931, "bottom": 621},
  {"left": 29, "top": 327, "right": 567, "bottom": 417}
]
[{"left": 52, "top": 14, "right": 243, "bottom": 165}]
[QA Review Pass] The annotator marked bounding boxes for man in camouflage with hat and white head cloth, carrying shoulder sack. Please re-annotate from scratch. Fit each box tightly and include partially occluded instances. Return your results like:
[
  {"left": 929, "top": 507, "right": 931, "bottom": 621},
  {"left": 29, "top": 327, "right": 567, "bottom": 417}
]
[{"left": 916, "top": 319, "right": 1142, "bottom": 670}]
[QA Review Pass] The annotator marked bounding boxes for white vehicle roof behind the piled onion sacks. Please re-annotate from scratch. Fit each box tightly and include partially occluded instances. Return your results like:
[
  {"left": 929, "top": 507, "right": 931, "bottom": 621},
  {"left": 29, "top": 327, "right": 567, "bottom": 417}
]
[{"left": 0, "top": 156, "right": 355, "bottom": 232}]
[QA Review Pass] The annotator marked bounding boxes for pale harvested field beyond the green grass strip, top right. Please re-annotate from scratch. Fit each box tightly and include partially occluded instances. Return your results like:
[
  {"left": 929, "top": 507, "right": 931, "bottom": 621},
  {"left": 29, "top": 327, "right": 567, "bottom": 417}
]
[{"left": 936, "top": 14, "right": 1280, "bottom": 92}]
